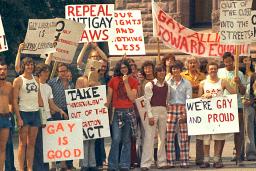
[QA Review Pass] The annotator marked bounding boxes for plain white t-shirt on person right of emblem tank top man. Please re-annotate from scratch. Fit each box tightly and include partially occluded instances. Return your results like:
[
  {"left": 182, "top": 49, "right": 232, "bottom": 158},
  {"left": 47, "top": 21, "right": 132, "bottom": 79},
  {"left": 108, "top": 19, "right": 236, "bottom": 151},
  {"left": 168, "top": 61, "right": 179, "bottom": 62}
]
[{"left": 40, "top": 83, "right": 53, "bottom": 119}]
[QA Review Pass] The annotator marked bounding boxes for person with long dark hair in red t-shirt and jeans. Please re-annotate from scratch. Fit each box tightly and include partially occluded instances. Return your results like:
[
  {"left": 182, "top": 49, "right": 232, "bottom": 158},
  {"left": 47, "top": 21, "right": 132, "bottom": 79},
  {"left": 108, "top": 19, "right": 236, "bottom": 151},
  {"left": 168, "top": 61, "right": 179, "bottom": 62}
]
[{"left": 106, "top": 60, "right": 138, "bottom": 171}]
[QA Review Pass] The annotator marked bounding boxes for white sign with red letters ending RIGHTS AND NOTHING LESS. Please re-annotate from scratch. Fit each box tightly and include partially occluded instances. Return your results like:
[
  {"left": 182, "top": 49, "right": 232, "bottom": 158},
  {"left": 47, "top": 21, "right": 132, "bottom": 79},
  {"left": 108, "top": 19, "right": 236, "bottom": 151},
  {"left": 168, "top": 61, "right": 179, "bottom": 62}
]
[{"left": 108, "top": 10, "right": 145, "bottom": 55}]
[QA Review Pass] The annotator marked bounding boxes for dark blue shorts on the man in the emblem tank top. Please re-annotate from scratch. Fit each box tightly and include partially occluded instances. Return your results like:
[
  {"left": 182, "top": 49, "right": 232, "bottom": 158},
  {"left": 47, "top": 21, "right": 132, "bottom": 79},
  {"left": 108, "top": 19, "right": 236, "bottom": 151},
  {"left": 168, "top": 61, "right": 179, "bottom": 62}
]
[{"left": 20, "top": 111, "right": 41, "bottom": 127}]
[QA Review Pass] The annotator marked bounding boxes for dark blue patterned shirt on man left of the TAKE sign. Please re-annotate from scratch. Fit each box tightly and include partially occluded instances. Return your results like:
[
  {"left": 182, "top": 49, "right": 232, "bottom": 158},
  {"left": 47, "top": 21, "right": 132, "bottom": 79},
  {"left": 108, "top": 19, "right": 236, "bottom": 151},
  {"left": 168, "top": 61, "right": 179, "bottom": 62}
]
[{"left": 48, "top": 77, "right": 75, "bottom": 110}]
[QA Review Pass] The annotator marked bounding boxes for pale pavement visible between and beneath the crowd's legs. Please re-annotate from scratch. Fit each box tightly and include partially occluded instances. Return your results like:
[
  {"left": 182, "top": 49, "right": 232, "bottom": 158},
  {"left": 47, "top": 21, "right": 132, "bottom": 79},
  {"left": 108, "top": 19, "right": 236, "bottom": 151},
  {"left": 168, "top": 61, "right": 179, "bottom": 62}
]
[{"left": 14, "top": 135, "right": 256, "bottom": 171}]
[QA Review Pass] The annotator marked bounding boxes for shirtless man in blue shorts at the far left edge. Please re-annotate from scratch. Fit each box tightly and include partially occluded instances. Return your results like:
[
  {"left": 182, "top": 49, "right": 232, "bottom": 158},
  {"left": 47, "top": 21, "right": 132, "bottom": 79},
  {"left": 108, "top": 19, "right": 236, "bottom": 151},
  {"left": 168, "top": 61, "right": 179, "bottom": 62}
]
[{"left": 0, "top": 61, "right": 12, "bottom": 171}]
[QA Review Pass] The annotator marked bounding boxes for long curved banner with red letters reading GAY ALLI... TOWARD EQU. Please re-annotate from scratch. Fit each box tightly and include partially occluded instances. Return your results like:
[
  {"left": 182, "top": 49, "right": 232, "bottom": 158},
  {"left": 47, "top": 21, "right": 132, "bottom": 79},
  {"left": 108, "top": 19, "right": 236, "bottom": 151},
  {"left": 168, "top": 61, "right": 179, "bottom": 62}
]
[{"left": 153, "top": 3, "right": 250, "bottom": 57}]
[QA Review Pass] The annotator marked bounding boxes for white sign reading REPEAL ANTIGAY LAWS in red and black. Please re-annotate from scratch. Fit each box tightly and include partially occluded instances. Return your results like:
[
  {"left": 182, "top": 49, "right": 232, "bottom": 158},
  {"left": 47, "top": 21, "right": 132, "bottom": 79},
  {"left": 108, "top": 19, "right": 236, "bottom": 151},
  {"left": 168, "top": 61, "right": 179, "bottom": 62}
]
[{"left": 65, "top": 4, "right": 114, "bottom": 42}]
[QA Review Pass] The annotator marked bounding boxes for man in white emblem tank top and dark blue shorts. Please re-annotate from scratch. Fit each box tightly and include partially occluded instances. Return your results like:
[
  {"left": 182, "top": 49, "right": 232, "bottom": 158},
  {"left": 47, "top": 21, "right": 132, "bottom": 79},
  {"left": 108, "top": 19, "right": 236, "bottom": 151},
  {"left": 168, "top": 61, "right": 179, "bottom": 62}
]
[{"left": 13, "top": 57, "right": 43, "bottom": 171}]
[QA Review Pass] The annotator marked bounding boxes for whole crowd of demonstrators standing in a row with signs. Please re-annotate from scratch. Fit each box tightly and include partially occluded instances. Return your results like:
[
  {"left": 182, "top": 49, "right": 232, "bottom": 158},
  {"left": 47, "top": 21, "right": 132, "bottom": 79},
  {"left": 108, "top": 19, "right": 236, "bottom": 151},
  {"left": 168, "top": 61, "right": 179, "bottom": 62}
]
[{"left": 0, "top": 44, "right": 256, "bottom": 171}]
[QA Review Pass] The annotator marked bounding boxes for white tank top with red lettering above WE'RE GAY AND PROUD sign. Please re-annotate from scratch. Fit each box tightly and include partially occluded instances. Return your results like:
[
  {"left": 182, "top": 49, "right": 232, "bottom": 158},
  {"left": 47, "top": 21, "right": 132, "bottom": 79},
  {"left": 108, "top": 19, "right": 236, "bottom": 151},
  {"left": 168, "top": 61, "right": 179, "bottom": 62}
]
[{"left": 204, "top": 79, "right": 223, "bottom": 97}]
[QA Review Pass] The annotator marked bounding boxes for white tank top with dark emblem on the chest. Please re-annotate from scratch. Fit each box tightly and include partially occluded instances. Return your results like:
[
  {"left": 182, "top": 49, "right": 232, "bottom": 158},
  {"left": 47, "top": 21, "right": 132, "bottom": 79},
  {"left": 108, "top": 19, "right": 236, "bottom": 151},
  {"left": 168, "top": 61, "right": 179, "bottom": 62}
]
[{"left": 19, "top": 75, "right": 39, "bottom": 112}]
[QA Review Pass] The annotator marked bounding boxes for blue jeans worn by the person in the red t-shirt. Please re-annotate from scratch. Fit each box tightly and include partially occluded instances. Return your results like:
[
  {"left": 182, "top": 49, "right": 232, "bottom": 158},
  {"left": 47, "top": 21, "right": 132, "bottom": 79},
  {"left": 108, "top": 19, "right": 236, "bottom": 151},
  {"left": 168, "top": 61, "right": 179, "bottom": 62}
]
[{"left": 108, "top": 109, "right": 131, "bottom": 170}]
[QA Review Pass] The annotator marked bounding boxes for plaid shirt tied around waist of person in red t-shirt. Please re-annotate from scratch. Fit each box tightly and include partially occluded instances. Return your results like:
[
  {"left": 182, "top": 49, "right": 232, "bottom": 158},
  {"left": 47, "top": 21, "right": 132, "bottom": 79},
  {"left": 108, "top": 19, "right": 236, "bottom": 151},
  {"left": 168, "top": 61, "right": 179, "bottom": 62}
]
[{"left": 116, "top": 109, "right": 137, "bottom": 136}]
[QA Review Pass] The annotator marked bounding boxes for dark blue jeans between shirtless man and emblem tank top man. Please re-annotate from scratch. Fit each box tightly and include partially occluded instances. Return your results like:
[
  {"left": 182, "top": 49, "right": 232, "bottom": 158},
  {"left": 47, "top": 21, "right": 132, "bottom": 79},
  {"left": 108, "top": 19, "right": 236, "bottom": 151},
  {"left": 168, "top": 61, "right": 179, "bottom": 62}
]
[{"left": 5, "top": 115, "right": 16, "bottom": 171}]
